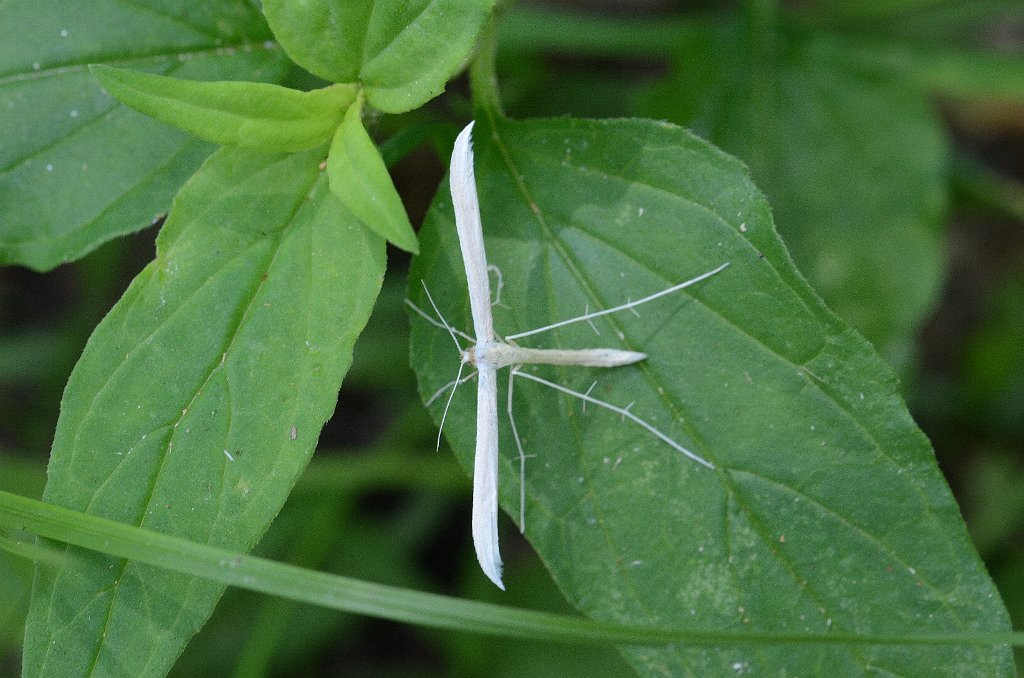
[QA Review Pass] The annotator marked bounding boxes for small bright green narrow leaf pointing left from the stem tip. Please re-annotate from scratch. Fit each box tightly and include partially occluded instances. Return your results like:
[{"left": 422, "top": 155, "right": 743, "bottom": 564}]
[{"left": 92, "top": 66, "right": 355, "bottom": 152}]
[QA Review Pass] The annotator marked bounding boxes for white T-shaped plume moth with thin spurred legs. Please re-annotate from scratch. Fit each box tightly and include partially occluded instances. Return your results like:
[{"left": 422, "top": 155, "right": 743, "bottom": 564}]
[{"left": 410, "top": 123, "right": 728, "bottom": 590}]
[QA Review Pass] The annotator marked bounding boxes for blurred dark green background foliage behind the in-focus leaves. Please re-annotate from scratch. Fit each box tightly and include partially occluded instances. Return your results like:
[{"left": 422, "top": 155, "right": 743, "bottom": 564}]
[{"left": 6, "top": 0, "right": 1024, "bottom": 676}]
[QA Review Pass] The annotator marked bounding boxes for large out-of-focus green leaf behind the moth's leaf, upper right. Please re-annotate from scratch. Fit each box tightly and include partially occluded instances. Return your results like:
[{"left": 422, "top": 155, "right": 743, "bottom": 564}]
[{"left": 651, "top": 27, "right": 948, "bottom": 365}]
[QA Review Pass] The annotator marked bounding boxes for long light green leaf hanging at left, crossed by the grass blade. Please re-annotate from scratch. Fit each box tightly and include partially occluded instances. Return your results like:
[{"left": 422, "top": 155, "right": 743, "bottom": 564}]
[{"left": 25, "top": 146, "right": 384, "bottom": 676}]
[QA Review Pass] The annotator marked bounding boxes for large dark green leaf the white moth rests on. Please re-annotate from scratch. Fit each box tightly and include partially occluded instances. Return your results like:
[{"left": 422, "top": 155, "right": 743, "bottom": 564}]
[{"left": 410, "top": 119, "right": 1013, "bottom": 676}]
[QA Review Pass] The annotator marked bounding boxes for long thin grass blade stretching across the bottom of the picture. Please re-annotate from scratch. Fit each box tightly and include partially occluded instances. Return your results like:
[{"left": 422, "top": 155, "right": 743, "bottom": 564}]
[{"left": 0, "top": 492, "right": 1024, "bottom": 646}]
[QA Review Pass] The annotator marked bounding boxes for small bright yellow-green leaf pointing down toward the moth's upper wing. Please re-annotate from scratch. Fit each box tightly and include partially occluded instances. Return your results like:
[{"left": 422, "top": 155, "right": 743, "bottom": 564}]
[{"left": 327, "top": 104, "right": 420, "bottom": 254}]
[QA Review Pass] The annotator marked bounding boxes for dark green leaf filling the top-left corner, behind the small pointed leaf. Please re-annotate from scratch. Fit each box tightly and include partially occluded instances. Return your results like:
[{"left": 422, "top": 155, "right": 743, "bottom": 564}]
[{"left": 0, "top": 0, "right": 289, "bottom": 269}]
